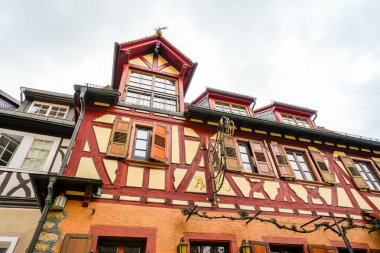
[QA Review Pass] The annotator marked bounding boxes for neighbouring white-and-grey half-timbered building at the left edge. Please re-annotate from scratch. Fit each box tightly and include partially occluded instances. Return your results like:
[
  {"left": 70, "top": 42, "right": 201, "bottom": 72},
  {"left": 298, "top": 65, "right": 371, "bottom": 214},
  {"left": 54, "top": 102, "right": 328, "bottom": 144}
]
[{"left": 0, "top": 87, "right": 74, "bottom": 252}]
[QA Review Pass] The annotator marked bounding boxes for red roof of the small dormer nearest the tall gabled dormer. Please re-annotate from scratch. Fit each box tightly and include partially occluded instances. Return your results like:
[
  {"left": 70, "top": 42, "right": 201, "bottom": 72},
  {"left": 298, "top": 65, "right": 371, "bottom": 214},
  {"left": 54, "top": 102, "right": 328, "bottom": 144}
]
[{"left": 191, "top": 87, "right": 256, "bottom": 105}]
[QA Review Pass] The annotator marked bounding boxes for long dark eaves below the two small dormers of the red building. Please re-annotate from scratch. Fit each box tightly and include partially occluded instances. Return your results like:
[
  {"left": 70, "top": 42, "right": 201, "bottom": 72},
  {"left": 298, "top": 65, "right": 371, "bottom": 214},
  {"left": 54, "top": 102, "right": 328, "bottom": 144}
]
[{"left": 186, "top": 105, "right": 380, "bottom": 150}]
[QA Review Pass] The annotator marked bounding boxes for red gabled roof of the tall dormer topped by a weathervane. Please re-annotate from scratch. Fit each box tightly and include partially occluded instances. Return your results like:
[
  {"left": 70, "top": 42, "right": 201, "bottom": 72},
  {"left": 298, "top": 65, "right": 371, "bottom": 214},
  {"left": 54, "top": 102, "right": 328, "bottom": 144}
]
[{"left": 112, "top": 35, "right": 198, "bottom": 94}]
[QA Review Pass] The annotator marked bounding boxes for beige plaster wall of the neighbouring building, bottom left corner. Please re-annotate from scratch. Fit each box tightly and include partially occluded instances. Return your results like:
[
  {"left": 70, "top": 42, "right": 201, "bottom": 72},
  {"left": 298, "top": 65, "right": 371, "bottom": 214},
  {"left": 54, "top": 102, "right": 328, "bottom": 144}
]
[{"left": 0, "top": 208, "right": 41, "bottom": 253}]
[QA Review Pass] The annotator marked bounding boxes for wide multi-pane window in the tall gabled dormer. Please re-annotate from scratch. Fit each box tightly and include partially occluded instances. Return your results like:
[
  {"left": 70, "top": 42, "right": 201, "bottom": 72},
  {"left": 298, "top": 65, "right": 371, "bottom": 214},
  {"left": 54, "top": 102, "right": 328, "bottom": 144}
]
[{"left": 125, "top": 72, "right": 178, "bottom": 112}]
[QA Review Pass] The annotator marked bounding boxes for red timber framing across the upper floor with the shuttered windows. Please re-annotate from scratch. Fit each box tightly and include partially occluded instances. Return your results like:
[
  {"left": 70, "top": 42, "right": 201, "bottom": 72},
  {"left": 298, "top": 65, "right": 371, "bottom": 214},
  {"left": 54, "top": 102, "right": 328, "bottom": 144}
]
[{"left": 66, "top": 103, "right": 378, "bottom": 222}]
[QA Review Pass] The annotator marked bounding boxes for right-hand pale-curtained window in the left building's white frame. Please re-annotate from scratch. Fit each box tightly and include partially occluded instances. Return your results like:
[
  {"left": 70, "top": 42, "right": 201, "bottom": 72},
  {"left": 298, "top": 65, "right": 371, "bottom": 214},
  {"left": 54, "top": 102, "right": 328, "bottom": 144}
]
[{"left": 21, "top": 139, "right": 53, "bottom": 170}]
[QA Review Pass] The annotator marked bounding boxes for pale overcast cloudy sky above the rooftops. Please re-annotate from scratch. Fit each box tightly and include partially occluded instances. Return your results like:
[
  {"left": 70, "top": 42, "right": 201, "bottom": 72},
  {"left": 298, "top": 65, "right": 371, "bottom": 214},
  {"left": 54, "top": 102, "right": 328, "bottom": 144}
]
[{"left": 0, "top": 0, "right": 380, "bottom": 139}]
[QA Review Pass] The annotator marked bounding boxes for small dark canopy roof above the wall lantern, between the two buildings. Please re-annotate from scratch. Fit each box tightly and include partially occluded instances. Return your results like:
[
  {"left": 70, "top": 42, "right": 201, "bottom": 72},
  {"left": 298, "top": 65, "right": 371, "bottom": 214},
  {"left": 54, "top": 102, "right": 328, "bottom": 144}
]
[{"left": 29, "top": 173, "right": 103, "bottom": 210}]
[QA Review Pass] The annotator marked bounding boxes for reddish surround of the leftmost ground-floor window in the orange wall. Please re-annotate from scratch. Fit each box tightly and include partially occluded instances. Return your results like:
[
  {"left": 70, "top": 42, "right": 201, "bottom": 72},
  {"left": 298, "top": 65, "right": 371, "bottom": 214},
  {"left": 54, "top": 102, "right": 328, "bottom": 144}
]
[{"left": 89, "top": 226, "right": 157, "bottom": 253}]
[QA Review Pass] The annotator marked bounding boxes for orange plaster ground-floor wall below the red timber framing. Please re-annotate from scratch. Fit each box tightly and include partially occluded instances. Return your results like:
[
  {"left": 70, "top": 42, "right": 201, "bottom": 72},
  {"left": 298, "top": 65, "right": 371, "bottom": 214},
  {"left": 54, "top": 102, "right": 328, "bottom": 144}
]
[{"left": 57, "top": 201, "right": 380, "bottom": 253}]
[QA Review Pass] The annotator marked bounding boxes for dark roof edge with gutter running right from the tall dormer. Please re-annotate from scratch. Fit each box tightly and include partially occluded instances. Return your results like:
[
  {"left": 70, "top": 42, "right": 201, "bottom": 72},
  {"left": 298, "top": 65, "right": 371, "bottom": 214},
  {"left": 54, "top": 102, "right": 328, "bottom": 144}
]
[{"left": 187, "top": 105, "right": 380, "bottom": 148}]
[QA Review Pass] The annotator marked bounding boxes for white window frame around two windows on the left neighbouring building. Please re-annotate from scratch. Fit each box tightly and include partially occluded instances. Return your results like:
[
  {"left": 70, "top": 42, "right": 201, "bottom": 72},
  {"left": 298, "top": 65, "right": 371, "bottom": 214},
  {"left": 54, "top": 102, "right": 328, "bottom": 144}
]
[{"left": 0, "top": 128, "right": 61, "bottom": 172}]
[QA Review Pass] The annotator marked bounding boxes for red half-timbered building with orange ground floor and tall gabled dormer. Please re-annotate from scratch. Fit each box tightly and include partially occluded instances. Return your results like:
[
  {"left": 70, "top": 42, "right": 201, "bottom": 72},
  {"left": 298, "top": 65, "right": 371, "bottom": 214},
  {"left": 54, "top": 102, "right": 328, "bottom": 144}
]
[{"left": 28, "top": 35, "right": 380, "bottom": 253}]
